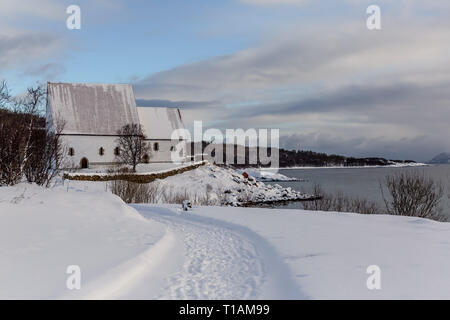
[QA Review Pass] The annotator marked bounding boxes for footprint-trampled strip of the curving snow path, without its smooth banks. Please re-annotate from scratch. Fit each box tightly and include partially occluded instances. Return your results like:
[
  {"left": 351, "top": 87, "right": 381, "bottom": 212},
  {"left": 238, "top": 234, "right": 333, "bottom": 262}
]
[{"left": 139, "top": 208, "right": 263, "bottom": 299}]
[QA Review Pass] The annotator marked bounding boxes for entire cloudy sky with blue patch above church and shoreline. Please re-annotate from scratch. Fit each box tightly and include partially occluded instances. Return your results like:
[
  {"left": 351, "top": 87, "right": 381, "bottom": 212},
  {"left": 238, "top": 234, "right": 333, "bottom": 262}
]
[{"left": 0, "top": 0, "right": 450, "bottom": 161}]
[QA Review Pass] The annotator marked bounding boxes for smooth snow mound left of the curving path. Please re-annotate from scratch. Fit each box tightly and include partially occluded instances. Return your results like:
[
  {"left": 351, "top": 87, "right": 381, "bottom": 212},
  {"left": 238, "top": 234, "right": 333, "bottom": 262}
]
[{"left": 0, "top": 184, "right": 165, "bottom": 299}]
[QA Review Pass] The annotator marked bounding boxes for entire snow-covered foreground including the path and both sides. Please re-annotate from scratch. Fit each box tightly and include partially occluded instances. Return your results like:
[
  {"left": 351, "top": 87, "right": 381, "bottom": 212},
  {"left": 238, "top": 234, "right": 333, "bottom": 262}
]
[{"left": 0, "top": 182, "right": 450, "bottom": 299}]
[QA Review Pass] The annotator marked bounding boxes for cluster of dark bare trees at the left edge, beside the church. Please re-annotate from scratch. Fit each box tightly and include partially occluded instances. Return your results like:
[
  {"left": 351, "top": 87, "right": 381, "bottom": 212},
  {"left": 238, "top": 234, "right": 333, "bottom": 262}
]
[{"left": 0, "top": 81, "right": 64, "bottom": 186}]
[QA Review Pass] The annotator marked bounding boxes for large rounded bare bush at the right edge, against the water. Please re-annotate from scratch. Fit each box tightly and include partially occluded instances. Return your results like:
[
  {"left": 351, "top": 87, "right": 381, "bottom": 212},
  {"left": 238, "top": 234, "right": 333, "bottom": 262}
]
[{"left": 381, "top": 171, "right": 447, "bottom": 221}]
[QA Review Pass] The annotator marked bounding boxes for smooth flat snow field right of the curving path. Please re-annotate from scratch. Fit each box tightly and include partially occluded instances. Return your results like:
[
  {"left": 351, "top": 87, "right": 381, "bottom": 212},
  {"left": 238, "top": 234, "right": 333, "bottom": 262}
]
[{"left": 177, "top": 207, "right": 450, "bottom": 299}]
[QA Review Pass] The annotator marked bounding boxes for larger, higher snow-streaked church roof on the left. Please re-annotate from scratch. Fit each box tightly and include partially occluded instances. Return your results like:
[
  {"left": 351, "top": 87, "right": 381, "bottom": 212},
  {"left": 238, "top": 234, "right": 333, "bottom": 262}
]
[{"left": 47, "top": 83, "right": 139, "bottom": 135}]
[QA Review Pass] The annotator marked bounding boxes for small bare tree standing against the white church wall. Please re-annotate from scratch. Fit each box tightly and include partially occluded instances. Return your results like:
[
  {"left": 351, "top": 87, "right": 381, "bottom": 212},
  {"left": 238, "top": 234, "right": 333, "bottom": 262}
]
[{"left": 116, "top": 123, "right": 150, "bottom": 171}]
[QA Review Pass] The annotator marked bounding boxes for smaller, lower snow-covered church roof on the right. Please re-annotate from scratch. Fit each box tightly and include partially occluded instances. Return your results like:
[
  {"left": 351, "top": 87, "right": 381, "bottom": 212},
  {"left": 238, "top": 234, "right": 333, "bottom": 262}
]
[{"left": 137, "top": 107, "right": 184, "bottom": 140}]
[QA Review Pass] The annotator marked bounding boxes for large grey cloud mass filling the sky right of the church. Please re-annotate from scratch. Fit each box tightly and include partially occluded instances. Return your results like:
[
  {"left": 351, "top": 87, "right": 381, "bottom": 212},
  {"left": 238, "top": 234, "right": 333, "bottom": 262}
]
[{"left": 136, "top": 13, "right": 450, "bottom": 160}]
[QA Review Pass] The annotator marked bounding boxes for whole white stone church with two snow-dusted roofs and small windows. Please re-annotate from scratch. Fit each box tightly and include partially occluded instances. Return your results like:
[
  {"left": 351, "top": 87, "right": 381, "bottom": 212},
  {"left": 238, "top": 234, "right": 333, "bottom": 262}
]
[{"left": 47, "top": 83, "right": 184, "bottom": 168}]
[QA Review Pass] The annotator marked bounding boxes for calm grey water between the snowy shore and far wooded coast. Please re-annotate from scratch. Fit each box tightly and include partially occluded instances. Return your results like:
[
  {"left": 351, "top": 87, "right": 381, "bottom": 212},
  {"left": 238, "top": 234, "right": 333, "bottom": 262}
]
[{"left": 271, "top": 165, "right": 450, "bottom": 215}]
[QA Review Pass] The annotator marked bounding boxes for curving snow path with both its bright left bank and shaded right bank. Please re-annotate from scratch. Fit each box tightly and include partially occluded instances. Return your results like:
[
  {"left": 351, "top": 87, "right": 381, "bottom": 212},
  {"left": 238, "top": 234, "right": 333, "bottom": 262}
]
[{"left": 67, "top": 205, "right": 305, "bottom": 299}]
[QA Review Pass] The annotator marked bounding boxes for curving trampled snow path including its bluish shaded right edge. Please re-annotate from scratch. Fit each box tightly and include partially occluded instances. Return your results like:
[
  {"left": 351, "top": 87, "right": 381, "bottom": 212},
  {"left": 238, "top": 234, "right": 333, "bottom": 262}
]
[{"left": 134, "top": 205, "right": 302, "bottom": 299}]
